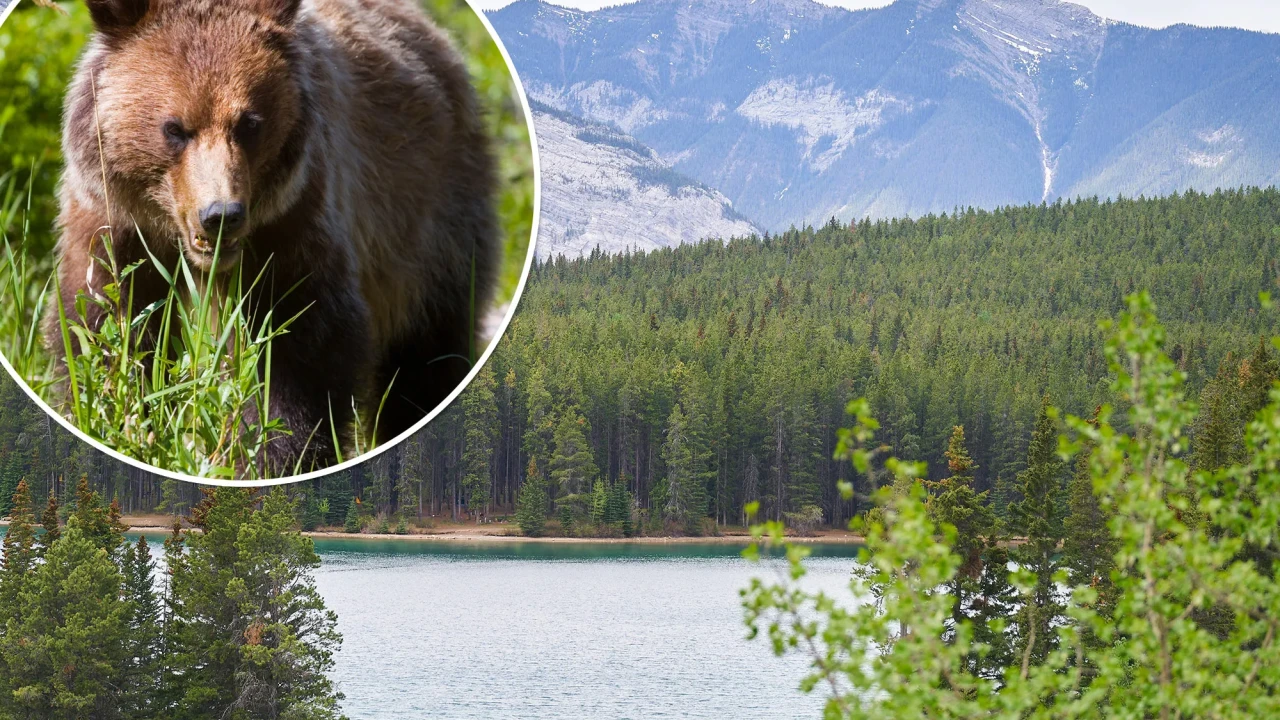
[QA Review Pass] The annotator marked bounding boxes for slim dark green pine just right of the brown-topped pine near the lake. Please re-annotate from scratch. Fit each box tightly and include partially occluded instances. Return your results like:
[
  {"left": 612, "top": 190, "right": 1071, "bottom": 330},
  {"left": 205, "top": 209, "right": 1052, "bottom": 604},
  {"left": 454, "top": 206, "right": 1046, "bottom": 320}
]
[{"left": 1010, "top": 396, "right": 1062, "bottom": 665}]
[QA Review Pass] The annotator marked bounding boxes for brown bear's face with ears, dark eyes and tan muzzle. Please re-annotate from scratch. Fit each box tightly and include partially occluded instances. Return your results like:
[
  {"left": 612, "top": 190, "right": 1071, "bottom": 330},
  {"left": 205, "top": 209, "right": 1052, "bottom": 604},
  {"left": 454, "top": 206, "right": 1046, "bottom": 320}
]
[{"left": 87, "top": 0, "right": 302, "bottom": 272}]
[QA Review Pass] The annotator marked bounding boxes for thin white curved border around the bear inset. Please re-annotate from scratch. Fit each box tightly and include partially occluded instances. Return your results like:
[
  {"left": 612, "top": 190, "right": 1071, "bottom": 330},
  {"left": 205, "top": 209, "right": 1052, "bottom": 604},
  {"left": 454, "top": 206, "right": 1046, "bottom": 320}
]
[{"left": 0, "top": 0, "right": 543, "bottom": 488}]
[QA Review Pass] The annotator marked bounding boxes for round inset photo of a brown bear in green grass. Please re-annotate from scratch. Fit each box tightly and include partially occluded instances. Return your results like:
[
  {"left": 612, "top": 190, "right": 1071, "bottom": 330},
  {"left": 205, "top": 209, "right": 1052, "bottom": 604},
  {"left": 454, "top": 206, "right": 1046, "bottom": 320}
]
[{"left": 0, "top": 0, "right": 539, "bottom": 484}]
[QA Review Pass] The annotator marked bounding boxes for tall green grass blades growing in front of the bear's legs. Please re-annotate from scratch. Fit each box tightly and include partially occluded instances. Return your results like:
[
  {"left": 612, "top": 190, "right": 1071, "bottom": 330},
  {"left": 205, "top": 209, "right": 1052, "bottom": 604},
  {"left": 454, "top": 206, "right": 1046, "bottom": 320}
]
[{"left": 0, "top": 170, "right": 325, "bottom": 479}]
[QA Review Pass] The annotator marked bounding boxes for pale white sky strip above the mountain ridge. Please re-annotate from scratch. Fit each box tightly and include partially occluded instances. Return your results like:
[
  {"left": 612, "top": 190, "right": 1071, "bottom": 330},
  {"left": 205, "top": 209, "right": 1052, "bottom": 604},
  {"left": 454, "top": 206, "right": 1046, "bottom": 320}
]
[{"left": 471, "top": 0, "right": 1280, "bottom": 32}]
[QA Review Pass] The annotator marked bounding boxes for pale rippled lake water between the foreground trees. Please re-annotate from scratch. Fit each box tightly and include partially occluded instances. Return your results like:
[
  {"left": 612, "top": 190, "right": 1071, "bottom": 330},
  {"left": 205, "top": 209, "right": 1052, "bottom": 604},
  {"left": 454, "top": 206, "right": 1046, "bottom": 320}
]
[{"left": 316, "top": 538, "right": 856, "bottom": 720}]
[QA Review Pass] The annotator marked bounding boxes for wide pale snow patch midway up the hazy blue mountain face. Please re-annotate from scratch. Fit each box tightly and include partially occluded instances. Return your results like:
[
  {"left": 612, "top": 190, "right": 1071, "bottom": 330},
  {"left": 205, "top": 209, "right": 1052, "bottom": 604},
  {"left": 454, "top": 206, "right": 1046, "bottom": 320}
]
[{"left": 737, "top": 78, "right": 914, "bottom": 173}]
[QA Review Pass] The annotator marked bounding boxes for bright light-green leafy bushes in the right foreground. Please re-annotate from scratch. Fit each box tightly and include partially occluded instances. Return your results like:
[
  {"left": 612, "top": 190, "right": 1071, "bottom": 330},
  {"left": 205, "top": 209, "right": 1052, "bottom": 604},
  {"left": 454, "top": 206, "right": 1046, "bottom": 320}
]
[{"left": 742, "top": 293, "right": 1280, "bottom": 719}]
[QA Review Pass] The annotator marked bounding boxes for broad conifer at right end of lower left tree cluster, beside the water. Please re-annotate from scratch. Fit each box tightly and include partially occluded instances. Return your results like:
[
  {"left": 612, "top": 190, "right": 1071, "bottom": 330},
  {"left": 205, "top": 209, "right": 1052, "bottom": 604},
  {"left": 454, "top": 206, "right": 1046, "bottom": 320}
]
[{"left": 168, "top": 488, "right": 342, "bottom": 720}]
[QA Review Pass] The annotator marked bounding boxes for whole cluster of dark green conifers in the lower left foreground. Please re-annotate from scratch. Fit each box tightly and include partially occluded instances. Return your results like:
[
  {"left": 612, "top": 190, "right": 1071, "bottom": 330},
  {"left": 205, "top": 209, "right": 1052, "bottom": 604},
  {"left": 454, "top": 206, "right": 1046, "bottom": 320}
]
[{"left": 0, "top": 482, "right": 342, "bottom": 720}]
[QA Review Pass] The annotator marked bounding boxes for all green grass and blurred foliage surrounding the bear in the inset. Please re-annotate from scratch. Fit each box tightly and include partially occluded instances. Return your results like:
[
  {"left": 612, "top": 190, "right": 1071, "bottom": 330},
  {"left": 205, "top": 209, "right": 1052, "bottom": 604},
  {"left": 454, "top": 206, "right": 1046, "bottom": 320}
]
[{"left": 0, "top": 0, "right": 534, "bottom": 479}]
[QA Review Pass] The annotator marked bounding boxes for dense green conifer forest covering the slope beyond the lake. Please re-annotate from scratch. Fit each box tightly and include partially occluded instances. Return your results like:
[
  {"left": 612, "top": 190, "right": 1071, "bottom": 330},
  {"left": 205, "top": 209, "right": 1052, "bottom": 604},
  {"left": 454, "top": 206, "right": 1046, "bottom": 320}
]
[{"left": 299, "top": 190, "right": 1280, "bottom": 532}]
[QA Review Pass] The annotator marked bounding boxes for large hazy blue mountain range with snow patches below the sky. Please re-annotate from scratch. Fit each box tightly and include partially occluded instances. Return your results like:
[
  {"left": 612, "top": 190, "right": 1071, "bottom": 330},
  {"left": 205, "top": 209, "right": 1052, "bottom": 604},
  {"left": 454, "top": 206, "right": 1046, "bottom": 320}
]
[{"left": 490, "top": 0, "right": 1280, "bottom": 234}]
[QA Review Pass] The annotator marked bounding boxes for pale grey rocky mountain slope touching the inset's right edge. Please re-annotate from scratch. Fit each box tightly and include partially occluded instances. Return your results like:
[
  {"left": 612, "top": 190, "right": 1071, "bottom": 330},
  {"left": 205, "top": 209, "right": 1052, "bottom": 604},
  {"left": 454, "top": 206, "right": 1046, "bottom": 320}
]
[{"left": 532, "top": 102, "right": 760, "bottom": 258}]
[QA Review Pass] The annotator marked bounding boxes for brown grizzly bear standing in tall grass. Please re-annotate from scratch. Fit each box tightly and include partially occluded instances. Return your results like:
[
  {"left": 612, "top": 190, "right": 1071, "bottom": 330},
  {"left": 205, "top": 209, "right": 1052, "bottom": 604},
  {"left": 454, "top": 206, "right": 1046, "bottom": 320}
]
[{"left": 46, "top": 0, "right": 498, "bottom": 474}]
